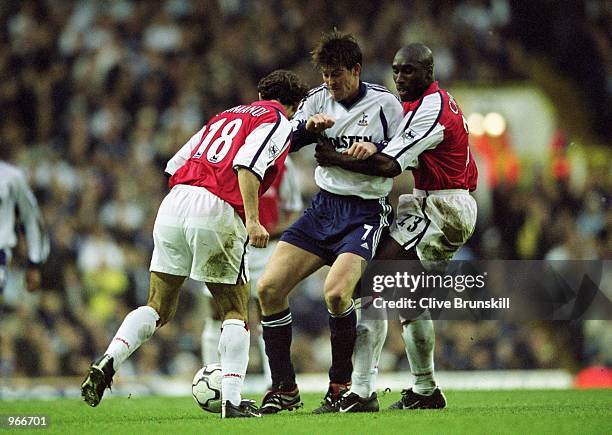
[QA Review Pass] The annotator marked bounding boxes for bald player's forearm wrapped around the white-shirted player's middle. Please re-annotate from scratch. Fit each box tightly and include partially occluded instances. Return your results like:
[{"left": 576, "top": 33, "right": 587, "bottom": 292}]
[{"left": 315, "top": 141, "right": 402, "bottom": 178}]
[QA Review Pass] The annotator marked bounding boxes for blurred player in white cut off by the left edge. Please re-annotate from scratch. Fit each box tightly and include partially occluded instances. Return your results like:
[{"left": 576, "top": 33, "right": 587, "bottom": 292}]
[{"left": 0, "top": 145, "right": 49, "bottom": 300}]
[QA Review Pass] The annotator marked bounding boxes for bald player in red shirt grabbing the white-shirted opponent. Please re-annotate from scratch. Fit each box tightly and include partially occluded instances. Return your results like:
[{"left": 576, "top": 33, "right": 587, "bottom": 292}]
[{"left": 317, "top": 43, "right": 478, "bottom": 412}]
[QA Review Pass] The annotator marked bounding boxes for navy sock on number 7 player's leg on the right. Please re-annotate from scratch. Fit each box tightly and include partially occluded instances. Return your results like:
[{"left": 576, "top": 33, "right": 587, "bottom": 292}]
[{"left": 329, "top": 301, "right": 357, "bottom": 384}]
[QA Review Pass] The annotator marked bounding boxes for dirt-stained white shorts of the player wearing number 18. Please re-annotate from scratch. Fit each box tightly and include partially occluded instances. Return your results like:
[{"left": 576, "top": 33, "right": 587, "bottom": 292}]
[{"left": 150, "top": 185, "right": 249, "bottom": 284}]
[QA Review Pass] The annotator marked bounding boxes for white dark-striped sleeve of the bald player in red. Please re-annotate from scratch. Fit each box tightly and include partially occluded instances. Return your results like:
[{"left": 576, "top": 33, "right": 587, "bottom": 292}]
[{"left": 381, "top": 92, "right": 444, "bottom": 170}]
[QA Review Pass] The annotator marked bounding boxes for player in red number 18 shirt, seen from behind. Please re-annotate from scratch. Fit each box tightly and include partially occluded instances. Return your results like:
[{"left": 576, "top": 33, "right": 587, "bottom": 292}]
[{"left": 81, "top": 70, "right": 307, "bottom": 418}]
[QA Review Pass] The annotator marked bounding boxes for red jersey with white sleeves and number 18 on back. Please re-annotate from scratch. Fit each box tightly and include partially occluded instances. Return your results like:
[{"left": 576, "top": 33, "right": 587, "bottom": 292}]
[{"left": 166, "top": 101, "right": 291, "bottom": 219}]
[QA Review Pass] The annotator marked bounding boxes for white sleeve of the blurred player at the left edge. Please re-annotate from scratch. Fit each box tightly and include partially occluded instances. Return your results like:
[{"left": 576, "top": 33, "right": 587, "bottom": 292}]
[{"left": 13, "top": 174, "right": 49, "bottom": 264}]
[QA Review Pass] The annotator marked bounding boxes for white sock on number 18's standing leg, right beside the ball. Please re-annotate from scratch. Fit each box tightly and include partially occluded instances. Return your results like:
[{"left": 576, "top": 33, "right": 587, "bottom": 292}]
[{"left": 219, "top": 319, "right": 251, "bottom": 405}]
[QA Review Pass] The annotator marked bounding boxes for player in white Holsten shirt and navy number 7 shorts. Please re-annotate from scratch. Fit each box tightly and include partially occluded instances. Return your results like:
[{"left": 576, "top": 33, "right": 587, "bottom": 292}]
[{"left": 257, "top": 30, "right": 402, "bottom": 413}]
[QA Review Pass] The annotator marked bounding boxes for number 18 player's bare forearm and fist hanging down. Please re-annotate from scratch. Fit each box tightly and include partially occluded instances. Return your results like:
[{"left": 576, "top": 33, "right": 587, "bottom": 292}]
[{"left": 238, "top": 167, "right": 270, "bottom": 248}]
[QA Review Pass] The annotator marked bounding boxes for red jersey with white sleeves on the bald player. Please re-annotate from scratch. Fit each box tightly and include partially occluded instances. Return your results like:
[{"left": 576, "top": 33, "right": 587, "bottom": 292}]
[{"left": 382, "top": 82, "right": 478, "bottom": 191}]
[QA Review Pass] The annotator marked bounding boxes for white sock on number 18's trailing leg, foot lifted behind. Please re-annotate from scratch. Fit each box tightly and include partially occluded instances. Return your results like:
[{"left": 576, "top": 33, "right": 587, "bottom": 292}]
[{"left": 105, "top": 306, "right": 159, "bottom": 371}]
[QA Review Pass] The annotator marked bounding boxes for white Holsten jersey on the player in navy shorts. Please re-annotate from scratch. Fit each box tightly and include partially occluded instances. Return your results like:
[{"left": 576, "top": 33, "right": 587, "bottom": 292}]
[{"left": 291, "top": 82, "right": 403, "bottom": 199}]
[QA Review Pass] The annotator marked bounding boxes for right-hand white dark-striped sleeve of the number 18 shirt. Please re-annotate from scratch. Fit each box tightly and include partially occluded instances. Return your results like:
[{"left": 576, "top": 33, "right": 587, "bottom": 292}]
[{"left": 233, "top": 112, "right": 291, "bottom": 180}]
